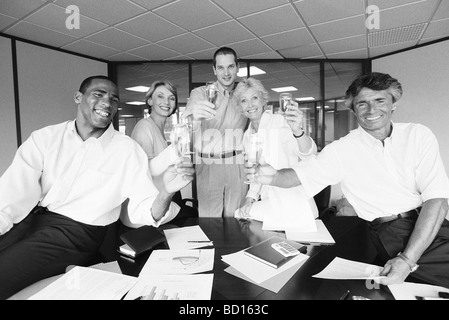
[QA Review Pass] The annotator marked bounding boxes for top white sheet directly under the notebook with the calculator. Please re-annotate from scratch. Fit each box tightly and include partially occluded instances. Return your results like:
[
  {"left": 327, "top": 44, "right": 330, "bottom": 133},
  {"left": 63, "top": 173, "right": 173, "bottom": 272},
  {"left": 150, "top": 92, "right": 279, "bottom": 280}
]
[{"left": 221, "top": 250, "right": 309, "bottom": 284}]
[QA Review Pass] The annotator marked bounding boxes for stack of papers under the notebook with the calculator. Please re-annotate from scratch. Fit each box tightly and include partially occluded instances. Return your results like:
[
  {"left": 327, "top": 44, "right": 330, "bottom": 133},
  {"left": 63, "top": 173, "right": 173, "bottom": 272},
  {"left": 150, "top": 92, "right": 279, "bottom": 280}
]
[{"left": 222, "top": 239, "right": 309, "bottom": 293}]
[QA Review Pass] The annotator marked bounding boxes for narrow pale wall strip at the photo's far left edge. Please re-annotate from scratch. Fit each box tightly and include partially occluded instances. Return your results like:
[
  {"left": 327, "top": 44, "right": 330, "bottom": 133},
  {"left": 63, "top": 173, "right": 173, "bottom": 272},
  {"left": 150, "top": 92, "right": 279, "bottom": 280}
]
[{"left": 0, "top": 37, "right": 17, "bottom": 174}]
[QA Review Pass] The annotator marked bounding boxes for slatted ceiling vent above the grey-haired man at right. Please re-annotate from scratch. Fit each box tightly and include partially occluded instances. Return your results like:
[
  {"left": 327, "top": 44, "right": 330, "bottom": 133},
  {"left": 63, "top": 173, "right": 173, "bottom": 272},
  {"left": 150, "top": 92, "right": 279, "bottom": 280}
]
[{"left": 368, "top": 22, "right": 427, "bottom": 48}]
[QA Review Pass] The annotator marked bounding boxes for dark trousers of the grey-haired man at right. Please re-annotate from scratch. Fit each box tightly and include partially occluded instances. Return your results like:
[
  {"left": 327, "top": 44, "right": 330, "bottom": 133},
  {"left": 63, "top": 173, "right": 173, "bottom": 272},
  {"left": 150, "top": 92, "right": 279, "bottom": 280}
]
[{"left": 368, "top": 215, "right": 449, "bottom": 288}]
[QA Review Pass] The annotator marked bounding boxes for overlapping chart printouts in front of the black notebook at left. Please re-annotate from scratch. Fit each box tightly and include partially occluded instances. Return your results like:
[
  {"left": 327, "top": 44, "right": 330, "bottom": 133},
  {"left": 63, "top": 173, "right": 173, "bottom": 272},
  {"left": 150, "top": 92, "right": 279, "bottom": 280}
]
[{"left": 125, "top": 225, "right": 215, "bottom": 300}]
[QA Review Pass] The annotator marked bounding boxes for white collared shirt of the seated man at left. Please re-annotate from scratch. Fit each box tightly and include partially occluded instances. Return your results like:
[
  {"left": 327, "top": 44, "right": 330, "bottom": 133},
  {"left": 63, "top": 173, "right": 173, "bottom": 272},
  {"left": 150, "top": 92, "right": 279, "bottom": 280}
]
[{"left": 0, "top": 121, "right": 179, "bottom": 234}]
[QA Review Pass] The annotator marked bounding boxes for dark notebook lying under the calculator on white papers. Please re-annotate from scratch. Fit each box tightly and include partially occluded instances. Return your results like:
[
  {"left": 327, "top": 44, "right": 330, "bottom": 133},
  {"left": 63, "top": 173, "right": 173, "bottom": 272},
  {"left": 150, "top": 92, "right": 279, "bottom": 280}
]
[{"left": 243, "top": 236, "right": 307, "bottom": 269}]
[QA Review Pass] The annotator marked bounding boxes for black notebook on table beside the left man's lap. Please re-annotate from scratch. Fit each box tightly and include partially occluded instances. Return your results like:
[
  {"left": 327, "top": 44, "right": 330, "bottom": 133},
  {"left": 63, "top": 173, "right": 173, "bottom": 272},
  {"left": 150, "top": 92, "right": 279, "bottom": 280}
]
[{"left": 119, "top": 226, "right": 166, "bottom": 258}]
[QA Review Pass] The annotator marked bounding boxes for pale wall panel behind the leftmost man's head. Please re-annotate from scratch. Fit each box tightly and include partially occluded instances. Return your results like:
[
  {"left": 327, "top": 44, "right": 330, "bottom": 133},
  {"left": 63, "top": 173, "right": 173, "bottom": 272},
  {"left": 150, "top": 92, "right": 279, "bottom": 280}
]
[{"left": 17, "top": 41, "right": 108, "bottom": 142}]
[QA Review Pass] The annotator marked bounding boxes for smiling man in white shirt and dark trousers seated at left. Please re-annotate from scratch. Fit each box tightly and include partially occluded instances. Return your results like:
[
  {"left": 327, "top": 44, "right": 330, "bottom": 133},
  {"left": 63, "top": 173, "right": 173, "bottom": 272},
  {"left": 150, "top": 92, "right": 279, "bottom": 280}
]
[{"left": 0, "top": 76, "right": 194, "bottom": 299}]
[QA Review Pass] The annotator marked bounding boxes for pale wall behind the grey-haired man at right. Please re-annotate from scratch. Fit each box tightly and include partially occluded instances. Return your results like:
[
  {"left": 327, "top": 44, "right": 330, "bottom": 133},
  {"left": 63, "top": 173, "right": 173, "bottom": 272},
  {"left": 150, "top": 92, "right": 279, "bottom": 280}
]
[{"left": 372, "top": 40, "right": 449, "bottom": 174}]
